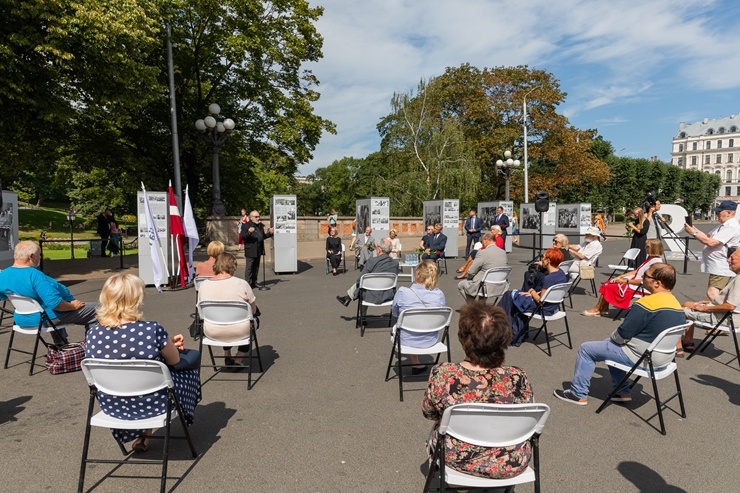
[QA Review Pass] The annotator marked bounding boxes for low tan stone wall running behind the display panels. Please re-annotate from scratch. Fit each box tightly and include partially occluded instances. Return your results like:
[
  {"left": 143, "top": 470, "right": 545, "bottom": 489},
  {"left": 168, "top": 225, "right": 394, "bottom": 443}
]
[{"left": 206, "top": 216, "right": 463, "bottom": 246}]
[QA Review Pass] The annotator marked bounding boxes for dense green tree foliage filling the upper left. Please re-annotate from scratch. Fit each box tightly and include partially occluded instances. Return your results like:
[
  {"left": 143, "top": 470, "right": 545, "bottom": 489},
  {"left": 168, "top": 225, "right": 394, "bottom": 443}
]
[{"left": 0, "top": 0, "right": 334, "bottom": 217}]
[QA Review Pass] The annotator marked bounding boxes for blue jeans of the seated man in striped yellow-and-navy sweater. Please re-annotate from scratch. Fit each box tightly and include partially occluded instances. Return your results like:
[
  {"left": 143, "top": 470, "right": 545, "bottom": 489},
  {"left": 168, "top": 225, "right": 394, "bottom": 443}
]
[{"left": 570, "top": 339, "right": 634, "bottom": 399}]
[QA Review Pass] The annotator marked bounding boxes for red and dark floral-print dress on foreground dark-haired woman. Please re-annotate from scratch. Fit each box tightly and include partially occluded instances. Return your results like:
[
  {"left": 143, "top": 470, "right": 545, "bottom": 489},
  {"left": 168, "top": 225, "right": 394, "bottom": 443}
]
[{"left": 421, "top": 363, "right": 534, "bottom": 479}]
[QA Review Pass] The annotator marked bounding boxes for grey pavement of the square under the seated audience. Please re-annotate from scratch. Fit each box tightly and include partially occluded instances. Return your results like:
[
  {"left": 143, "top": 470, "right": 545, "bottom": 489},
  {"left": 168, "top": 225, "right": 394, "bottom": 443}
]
[{"left": 0, "top": 232, "right": 740, "bottom": 493}]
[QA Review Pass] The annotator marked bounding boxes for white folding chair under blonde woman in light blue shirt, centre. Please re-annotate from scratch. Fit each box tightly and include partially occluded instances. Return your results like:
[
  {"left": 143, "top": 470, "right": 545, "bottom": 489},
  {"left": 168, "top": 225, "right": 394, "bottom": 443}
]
[{"left": 385, "top": 306, "right": 452, "bottom": 402}]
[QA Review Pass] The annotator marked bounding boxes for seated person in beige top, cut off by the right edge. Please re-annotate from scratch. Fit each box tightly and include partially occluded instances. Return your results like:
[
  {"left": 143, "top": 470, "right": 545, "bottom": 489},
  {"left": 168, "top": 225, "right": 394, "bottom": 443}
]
[{"left": 680, "top": 248, "right": 740, "bottom": 356}]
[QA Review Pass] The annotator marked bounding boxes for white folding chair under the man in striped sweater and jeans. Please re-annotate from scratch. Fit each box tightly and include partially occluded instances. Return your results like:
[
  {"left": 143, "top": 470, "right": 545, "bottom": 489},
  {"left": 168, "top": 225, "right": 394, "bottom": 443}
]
[{"left": 596, "top": 322, "right": 691, "bottom": 435}]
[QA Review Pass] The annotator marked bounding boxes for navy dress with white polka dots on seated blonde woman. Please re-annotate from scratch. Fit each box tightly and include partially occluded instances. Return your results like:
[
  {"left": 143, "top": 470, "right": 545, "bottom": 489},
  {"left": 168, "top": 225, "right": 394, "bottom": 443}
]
[{"left": 85, "top": 321, "right": 202, "bottom": 443}]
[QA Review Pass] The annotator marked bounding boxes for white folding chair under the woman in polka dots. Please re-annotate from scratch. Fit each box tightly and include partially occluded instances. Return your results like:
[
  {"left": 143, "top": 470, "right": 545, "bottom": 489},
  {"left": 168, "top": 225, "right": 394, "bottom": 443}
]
[{"left": 77, "top": 358, "right": 198, "bottom": 493}]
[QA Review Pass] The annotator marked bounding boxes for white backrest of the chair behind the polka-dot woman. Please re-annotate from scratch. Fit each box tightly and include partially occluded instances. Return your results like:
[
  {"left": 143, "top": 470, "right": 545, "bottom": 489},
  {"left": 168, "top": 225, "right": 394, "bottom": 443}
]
[{"left": 81, "top": 358, "right": 175, "bottom": 397}]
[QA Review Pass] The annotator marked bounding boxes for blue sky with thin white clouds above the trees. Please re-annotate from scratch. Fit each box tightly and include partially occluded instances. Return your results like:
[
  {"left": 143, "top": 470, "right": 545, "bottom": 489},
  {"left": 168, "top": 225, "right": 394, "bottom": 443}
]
[{"left": 298, "top": 0, "right": 740, "bottom": 175}]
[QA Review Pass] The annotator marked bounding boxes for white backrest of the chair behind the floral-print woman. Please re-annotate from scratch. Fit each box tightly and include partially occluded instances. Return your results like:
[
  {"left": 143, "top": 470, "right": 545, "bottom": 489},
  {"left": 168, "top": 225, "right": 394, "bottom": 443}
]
[{"left": 439, "top": 403, "right": 550, "bottom": 447}]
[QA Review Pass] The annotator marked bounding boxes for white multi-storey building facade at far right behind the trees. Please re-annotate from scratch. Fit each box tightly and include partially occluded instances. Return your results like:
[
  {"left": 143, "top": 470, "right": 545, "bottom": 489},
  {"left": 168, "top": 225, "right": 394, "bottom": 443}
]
[{"left": 671, "top": 114, "right": 740, "bottom": 201}]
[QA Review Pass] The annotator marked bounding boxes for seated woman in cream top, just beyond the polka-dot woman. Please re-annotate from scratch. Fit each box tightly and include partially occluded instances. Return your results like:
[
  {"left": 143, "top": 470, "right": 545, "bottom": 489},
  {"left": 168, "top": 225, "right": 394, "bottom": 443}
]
[{"left": 198, "top": 252, "right": 259, "bottom": 371}]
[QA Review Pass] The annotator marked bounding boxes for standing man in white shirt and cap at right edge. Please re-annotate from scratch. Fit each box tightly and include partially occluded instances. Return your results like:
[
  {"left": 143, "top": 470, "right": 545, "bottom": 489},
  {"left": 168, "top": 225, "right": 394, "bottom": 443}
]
[{"left": 684, "top": 200, "right": 740, "bottom": 300}]
